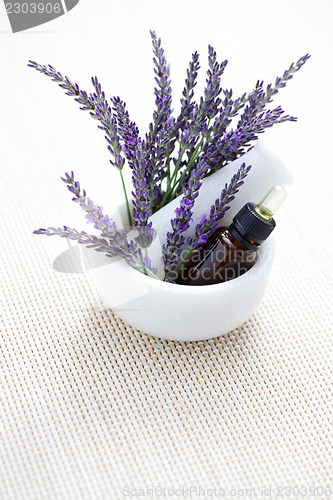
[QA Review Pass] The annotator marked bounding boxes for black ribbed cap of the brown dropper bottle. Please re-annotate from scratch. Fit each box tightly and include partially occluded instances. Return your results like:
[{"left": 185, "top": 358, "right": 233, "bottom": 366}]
[{"left": 229, "top": 203, "right": 276, "bottom": 250}]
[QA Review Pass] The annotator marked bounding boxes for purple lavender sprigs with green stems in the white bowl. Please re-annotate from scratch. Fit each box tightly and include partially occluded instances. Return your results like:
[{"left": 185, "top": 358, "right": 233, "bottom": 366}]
[{"left": 29, "top": 31, "right": 310, "bottom": 281}]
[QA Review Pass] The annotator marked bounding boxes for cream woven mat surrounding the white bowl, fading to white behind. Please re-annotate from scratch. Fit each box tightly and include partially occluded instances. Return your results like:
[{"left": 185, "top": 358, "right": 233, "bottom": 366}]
[{"left": 0, "top": 0, "right": 333, "bottom": 500}]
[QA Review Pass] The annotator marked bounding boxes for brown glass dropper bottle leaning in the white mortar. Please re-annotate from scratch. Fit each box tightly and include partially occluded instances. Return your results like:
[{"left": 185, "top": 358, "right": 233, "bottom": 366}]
[{"left": 176, "top": 186, "right": 287, "bottom": 285}]
